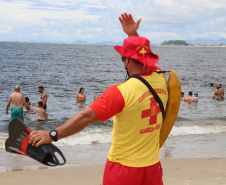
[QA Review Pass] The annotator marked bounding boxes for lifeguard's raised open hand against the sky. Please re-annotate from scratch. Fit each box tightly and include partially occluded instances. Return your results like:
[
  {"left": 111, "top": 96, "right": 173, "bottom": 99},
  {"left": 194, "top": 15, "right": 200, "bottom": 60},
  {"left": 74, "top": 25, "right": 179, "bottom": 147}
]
[{"left": 119, "top": 13, "right": 141, "bottom": 37}]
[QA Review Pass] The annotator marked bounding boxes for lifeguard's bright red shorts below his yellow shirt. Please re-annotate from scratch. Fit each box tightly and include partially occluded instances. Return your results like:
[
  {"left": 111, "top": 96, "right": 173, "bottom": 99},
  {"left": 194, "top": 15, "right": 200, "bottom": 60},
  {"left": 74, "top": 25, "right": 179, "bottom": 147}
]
[{"left": 103, "top": 160, "right": 163, "bottom": 185}]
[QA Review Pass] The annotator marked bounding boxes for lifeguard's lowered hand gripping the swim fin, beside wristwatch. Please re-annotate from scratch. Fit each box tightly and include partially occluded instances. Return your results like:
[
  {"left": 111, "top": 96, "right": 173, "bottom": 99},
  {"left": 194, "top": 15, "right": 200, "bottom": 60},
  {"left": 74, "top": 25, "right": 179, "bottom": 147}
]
[{"left": 29, "top": 130, "right": 53, "bottom": 147}]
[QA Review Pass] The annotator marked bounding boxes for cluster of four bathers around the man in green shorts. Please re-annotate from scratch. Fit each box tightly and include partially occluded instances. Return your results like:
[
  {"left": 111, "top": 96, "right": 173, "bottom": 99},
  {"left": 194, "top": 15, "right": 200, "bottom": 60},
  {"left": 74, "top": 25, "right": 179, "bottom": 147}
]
[{"left": 6, "top": 85, "right": 48, "bottom": 121}]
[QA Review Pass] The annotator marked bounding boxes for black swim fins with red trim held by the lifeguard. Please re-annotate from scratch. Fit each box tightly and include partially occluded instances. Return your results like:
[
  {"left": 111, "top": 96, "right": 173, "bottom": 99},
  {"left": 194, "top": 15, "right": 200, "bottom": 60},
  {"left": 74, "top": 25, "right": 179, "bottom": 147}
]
[{"left": 5, "top": 117, "right": 66, "bottom": 166}]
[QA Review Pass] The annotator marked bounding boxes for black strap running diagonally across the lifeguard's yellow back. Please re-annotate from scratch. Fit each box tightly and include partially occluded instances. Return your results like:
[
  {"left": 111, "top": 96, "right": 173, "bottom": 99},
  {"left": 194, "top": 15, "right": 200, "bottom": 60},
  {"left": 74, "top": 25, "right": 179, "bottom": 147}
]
[{"left": 130, "top": 74, "right": 165, "bottom": 119}]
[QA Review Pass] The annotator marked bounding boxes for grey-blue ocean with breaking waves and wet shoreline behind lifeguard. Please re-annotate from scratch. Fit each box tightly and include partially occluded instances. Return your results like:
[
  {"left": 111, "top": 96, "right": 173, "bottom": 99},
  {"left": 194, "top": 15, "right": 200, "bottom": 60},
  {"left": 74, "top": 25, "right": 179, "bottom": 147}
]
[{"left": 0, "top": 42, "right": 226, "bottom": 171}]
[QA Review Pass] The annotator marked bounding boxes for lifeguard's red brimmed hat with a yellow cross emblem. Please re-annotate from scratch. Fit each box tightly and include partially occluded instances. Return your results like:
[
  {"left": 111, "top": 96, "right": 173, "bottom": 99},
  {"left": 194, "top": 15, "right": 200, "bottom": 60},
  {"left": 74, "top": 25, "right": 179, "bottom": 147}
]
[{"left": 114, "top": 36, "right": 159, "bottom": 66}]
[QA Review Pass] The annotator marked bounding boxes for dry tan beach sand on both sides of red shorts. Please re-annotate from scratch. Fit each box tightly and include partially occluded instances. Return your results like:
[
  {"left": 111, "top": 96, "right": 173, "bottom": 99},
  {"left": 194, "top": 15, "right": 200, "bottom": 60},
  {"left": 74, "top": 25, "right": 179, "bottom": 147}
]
[{"left": 0, "top": 158, "right": 226, "bottom": 185}]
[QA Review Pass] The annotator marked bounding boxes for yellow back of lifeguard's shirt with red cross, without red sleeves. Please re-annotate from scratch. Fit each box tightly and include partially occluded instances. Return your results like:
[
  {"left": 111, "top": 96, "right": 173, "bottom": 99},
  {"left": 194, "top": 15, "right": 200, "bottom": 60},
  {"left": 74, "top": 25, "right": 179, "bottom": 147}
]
[{"left": 108, "top": 73, "right": 168, "bottom": 167}]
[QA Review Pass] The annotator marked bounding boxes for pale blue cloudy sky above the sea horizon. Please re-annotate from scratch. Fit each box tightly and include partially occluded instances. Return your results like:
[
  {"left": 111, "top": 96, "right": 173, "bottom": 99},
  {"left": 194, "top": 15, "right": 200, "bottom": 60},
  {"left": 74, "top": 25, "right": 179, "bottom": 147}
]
[{"left": 0, "top": 0, "right": 226, "bottom": 43}]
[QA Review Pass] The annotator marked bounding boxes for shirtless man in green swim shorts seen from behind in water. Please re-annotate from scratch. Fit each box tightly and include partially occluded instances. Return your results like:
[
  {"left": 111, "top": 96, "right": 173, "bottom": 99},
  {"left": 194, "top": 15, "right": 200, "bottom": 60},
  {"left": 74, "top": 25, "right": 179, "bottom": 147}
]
[{"left": 6, "top": 85, "right": 30, "bottom": 121}]
